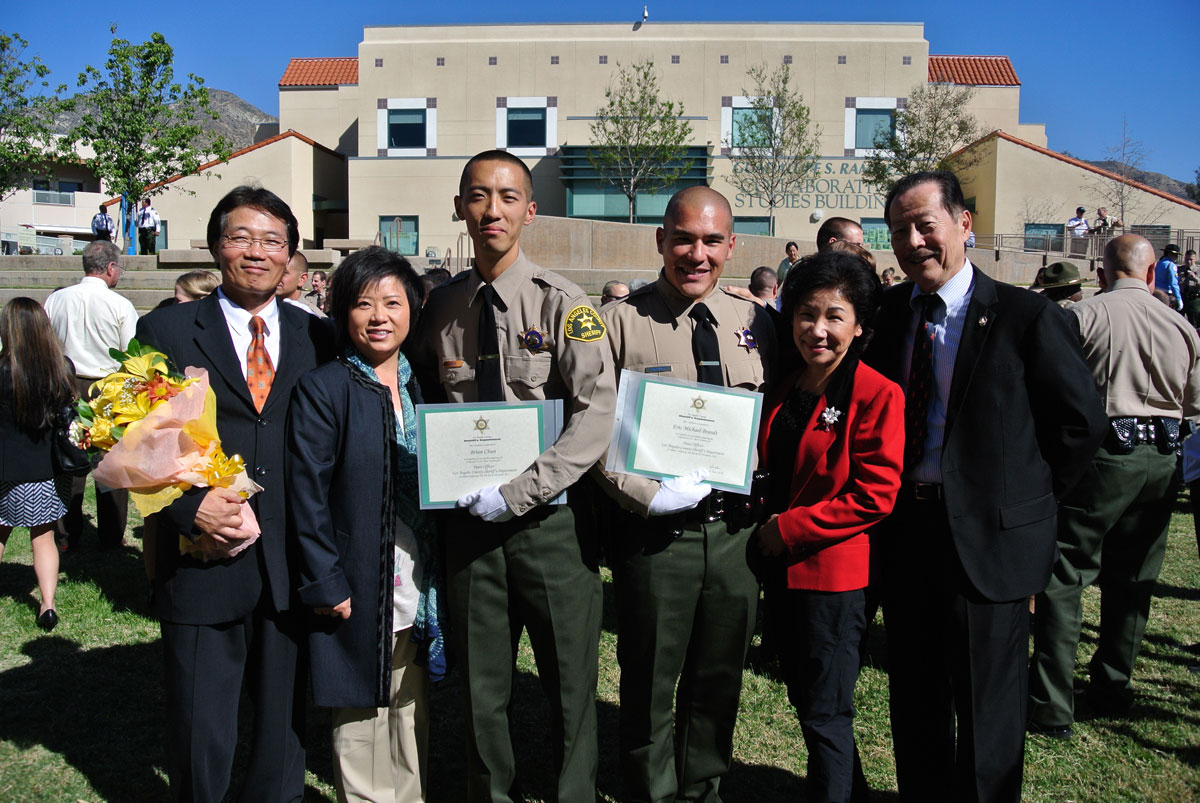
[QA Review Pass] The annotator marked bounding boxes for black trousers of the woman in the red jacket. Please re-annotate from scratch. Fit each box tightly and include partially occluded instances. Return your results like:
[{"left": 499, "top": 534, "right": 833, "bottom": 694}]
[{"left": 776, "top": 588, "right": 868, "bottom": 803}]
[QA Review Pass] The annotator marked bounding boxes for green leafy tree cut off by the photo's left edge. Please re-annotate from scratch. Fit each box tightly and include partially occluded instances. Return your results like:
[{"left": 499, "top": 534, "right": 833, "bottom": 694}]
[{"left": 0, "top": 31, "right": 66, "bottom": 200}]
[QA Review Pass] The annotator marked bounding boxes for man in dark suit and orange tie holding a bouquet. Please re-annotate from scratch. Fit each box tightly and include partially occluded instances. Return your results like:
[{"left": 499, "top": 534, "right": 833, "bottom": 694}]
[{"left": 137, "top": 187, "right": 332, "bottom": 801}]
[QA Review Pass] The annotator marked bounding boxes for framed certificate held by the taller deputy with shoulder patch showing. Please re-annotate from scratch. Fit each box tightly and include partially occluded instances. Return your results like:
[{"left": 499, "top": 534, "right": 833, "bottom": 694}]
[{"left": 416, "top": 400, "right": 563, "bottom": 509}]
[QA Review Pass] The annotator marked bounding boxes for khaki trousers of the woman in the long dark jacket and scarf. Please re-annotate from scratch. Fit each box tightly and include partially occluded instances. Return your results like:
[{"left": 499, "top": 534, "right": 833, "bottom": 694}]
[{"left": 332, "top": 628, "right": 430, "bottom": 803}]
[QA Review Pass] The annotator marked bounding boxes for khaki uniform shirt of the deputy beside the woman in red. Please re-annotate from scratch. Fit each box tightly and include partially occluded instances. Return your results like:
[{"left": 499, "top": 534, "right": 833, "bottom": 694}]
[{"left": 594, "top": 274, "right": 775, "bottom": 517}]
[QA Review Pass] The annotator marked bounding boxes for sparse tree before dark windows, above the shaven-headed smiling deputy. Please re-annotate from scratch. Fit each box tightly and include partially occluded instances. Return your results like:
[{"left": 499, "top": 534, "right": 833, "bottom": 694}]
[{"left": 588, "top": 59, "right": 691, "bottom": 223}]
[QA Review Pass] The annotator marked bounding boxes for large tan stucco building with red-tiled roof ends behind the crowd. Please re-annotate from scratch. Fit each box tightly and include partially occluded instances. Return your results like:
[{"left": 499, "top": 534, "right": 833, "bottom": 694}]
[{"left": 270, "top": 23, "right": 1045, "bottom": 256}]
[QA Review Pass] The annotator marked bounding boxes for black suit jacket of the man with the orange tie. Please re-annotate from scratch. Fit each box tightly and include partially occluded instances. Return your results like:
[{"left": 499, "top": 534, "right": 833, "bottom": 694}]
[{"left": 137, "top": 293, "right": 334, "bottom": 624}]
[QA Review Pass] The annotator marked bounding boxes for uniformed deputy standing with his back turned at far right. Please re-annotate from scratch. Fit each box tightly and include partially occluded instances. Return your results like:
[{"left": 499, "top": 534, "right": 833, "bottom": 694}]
[{"left": 1028, "top": 234, "right": 1200, "bottom": 738}]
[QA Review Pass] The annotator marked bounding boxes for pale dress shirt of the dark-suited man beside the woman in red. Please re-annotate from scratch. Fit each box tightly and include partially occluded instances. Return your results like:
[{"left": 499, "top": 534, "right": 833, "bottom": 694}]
[{"left": 904, "top": 259, "right": 974, "bottom": 483}]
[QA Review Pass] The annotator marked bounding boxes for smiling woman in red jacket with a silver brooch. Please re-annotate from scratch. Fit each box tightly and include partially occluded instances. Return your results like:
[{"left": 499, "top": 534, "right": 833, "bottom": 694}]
[{"left": 758, "top": 252, "right": 904, "bottom": 801}]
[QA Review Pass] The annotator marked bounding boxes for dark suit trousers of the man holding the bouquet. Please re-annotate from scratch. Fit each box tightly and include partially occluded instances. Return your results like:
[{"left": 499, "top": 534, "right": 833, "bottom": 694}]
[{"left": 162, "top": 603, "right": 305, "bottom": 803}]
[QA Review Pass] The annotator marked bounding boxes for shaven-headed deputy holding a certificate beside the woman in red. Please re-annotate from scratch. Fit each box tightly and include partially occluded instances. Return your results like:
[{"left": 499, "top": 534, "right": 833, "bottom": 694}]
[{"left": 595, "top": 187, "right": 775, "bottom": 801}]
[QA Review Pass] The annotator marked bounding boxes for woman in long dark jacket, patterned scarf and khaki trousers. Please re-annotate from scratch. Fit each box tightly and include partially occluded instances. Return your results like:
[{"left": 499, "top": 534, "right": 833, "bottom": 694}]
[{"left": 287, "top": 247, "right": 445, "bottom": 801}]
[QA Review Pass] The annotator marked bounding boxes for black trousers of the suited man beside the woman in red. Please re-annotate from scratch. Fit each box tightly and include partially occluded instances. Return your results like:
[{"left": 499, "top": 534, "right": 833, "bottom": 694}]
[{"left": 872, "top": 496, "right": 1030, "bottom": 803}]
